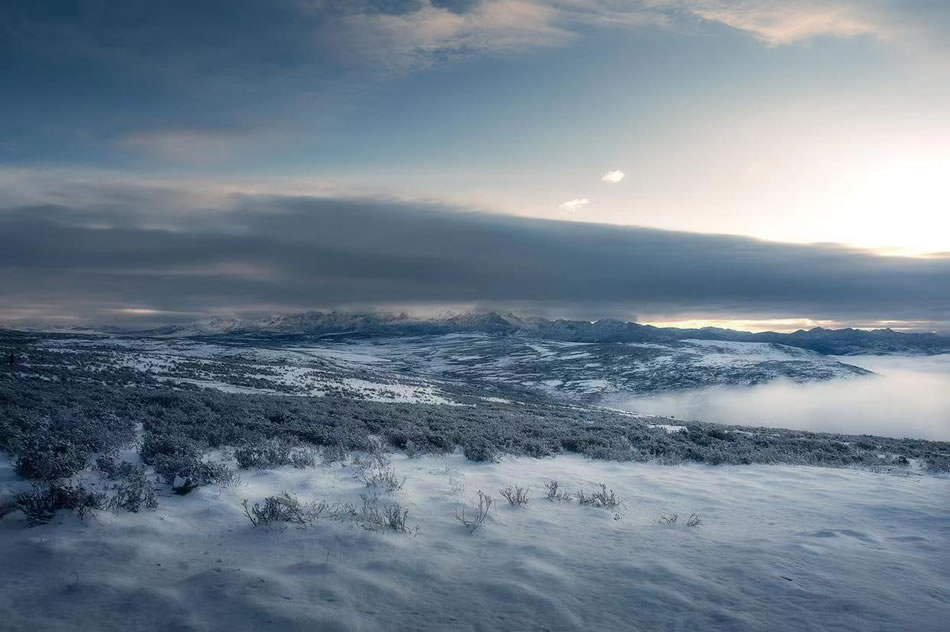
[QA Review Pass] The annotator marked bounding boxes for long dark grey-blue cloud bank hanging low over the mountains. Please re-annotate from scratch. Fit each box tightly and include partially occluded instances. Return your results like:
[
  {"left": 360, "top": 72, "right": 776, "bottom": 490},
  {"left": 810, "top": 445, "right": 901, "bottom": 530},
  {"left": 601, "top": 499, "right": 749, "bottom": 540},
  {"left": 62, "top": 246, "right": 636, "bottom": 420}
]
[{"left": 0, "top": 179, "right": 950, "bottom": 323}]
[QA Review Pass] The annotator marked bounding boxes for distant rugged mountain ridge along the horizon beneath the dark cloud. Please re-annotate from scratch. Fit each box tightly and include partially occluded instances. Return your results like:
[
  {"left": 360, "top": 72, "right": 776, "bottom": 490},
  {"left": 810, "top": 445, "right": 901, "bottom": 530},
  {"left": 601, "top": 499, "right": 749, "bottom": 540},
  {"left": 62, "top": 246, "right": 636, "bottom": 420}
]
[{"left": 130, "top": 312, "right": 950, "bottom": 355}]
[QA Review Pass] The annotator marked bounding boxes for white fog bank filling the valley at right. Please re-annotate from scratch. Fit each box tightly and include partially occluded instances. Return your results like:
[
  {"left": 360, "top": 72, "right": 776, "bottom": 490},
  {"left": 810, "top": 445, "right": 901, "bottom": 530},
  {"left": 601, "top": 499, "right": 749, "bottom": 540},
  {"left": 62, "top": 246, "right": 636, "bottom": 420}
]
[{"left": 613, "top": 355, "right": 950, "bottom": 441}]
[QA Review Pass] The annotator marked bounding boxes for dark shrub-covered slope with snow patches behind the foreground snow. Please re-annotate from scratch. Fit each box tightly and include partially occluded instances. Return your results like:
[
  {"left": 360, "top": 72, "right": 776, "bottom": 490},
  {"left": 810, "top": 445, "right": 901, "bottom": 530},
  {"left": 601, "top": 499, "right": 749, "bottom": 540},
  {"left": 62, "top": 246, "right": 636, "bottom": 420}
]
[{"left": 0, "top": 334, "right": 950, "bottom": 471}]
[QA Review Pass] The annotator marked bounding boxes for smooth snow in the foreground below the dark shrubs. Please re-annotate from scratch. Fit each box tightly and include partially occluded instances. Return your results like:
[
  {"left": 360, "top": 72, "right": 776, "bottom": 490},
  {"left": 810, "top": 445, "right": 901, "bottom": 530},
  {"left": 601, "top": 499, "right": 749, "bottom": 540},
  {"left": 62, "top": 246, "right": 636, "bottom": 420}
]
[{"left": 0, "top": 455, "right": 950, "bottom": 632}]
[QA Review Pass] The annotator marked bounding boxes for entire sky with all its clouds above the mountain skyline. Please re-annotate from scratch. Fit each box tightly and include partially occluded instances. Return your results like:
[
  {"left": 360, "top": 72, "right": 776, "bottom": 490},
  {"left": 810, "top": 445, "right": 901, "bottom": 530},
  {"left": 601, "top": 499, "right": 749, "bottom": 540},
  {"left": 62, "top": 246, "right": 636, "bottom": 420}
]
[{"left": 0, "top": 0, "right": 950, "bottom": 330}]
